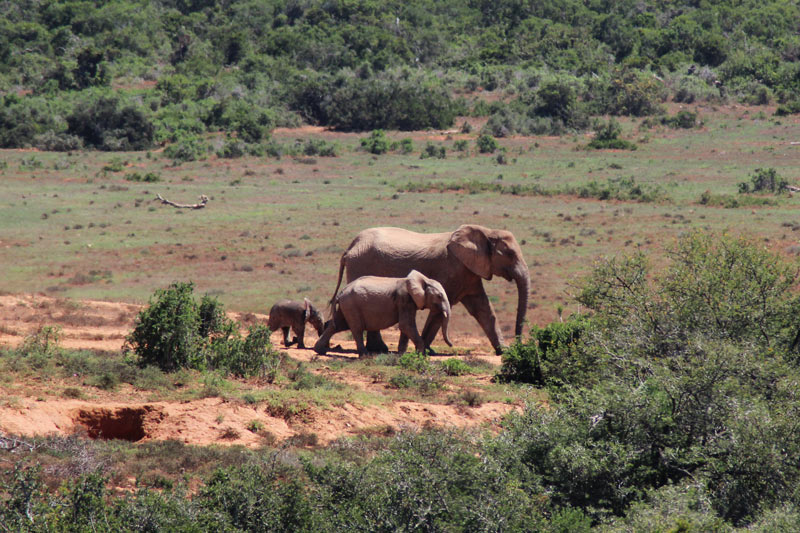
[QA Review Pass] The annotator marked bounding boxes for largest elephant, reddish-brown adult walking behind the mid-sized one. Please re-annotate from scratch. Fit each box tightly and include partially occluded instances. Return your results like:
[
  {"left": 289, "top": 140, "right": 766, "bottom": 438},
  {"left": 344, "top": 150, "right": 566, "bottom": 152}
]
[{"left": 333, "top": 224, "right": 530, "bottom": 354}]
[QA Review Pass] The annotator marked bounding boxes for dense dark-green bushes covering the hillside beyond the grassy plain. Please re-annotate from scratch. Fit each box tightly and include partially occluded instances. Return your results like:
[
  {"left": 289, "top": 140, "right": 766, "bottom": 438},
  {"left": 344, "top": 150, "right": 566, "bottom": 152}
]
[{"left": 0, "top": 0, "right": 800, "bottom": 152}]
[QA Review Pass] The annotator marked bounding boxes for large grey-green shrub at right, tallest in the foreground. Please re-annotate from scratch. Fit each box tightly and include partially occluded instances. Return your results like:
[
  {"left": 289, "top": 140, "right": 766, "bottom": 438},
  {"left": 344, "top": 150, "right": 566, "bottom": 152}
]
[{"left": 500, "top": 233, "right": 800, "bottom": 524}]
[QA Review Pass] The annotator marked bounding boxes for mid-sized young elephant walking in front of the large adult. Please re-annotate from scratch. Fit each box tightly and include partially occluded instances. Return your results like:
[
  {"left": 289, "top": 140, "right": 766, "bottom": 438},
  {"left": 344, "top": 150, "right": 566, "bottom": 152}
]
[{"left": 314, "top": 270, "right": 452, "bottom": 356}]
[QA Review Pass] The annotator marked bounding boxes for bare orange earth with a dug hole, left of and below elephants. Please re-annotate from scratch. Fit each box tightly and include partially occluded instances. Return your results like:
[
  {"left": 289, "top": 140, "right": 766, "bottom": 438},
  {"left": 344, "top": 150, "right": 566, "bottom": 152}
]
[{"left": 0, "top": 295, "right": 515, "bottom": 447}]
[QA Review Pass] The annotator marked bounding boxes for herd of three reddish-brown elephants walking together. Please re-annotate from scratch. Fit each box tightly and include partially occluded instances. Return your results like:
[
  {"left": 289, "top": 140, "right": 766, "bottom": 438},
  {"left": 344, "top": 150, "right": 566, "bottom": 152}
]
[{"left": 268, "top": 224, "right": 530, "bottom": 356}]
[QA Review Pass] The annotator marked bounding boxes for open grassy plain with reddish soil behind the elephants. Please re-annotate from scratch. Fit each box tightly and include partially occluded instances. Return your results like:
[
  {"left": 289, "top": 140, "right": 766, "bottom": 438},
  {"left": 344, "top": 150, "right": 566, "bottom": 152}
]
[{"left": 0, "top": 106, "right": 800, "bottom": 333}]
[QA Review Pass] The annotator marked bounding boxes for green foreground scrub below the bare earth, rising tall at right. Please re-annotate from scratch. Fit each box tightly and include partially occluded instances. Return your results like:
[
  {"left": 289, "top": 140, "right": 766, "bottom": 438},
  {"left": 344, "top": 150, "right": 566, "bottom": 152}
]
[{"left": 2, "top": 233, "right": 800, "bottom": 531}]
